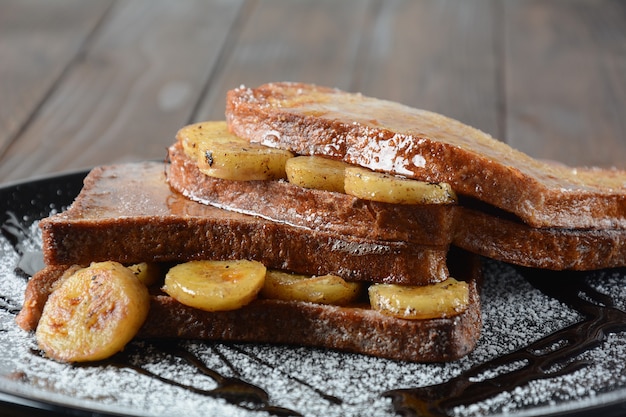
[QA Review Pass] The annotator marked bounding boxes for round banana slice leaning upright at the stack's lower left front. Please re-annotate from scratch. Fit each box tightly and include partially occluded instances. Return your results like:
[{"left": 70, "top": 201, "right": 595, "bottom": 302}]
[{"left": 36, "top": 262, "right": 150, "bottom": 362}]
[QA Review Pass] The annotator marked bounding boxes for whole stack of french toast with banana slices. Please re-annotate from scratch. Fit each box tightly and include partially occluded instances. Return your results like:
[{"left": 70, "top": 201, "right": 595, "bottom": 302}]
[{"left": 17, "top": 83, "right": 626, "bottom": 362}]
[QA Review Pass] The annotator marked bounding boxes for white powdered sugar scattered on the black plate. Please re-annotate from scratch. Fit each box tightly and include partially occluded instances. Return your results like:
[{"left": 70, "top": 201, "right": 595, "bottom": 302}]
[{"left": 0, "top": 213, "right": 626, "bottom": 417}]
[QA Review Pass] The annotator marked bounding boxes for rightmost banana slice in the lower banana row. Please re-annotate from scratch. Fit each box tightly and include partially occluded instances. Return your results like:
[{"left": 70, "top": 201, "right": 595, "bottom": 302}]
[{"left": 368, "top": 278, "right": 469, "bottom": 319}]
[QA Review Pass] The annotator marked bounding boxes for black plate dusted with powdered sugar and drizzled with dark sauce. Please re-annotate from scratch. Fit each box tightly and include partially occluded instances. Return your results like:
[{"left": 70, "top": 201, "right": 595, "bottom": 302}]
[{"left": 0, "top": 172, "right": 626, "bottom": 417}]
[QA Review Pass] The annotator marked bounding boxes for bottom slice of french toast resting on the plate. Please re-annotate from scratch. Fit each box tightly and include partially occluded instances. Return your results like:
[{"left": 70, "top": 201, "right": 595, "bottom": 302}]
[{"left": 17, "top": 250, "right": 482, "bottom": 362}]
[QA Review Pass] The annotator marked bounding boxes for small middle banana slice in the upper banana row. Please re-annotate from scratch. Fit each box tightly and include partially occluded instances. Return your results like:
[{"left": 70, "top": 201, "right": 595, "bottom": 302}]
[{"left": 285, "top": 156, "right": 349, "bottom": 193}]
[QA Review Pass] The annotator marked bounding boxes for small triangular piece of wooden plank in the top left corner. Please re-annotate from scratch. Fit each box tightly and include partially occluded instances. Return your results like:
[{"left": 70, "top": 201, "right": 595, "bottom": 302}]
[{"left": 0, "top": 0, "right": 111, "bottom": 155}]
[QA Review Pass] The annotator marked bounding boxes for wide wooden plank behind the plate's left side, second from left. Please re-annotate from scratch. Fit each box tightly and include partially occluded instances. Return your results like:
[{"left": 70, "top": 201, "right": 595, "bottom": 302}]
[{"left": 0, "top": 0, "right": 241, "bottom": 180}]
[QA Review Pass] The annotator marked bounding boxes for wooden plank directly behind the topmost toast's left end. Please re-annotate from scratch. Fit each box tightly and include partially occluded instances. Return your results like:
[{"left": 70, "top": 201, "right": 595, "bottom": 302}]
[{"left": 194, "top": 0, "right": 370, "bottom": 120}]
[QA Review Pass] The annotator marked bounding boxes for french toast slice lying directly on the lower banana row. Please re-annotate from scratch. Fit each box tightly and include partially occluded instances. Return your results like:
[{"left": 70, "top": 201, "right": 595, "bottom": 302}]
[{"left": 40, "top": 162, "right": 448, "bottom": 285}]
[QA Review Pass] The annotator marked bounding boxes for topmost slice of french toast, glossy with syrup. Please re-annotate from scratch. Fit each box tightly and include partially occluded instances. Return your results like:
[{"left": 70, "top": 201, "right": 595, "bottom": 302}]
[{"left": 226, "top": 83, "right": 626, "bottom": 229}]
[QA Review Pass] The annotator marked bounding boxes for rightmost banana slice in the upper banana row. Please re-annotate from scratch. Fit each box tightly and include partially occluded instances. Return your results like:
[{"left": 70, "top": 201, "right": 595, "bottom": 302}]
[{"left": 344, "top": 167, "right": 457, "bottom": 204}]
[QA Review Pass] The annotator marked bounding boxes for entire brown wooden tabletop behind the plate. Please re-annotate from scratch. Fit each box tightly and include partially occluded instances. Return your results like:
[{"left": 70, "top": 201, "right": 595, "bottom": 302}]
[{"left": 0, "top": 0, "right": 626, "bottom": 183}]
